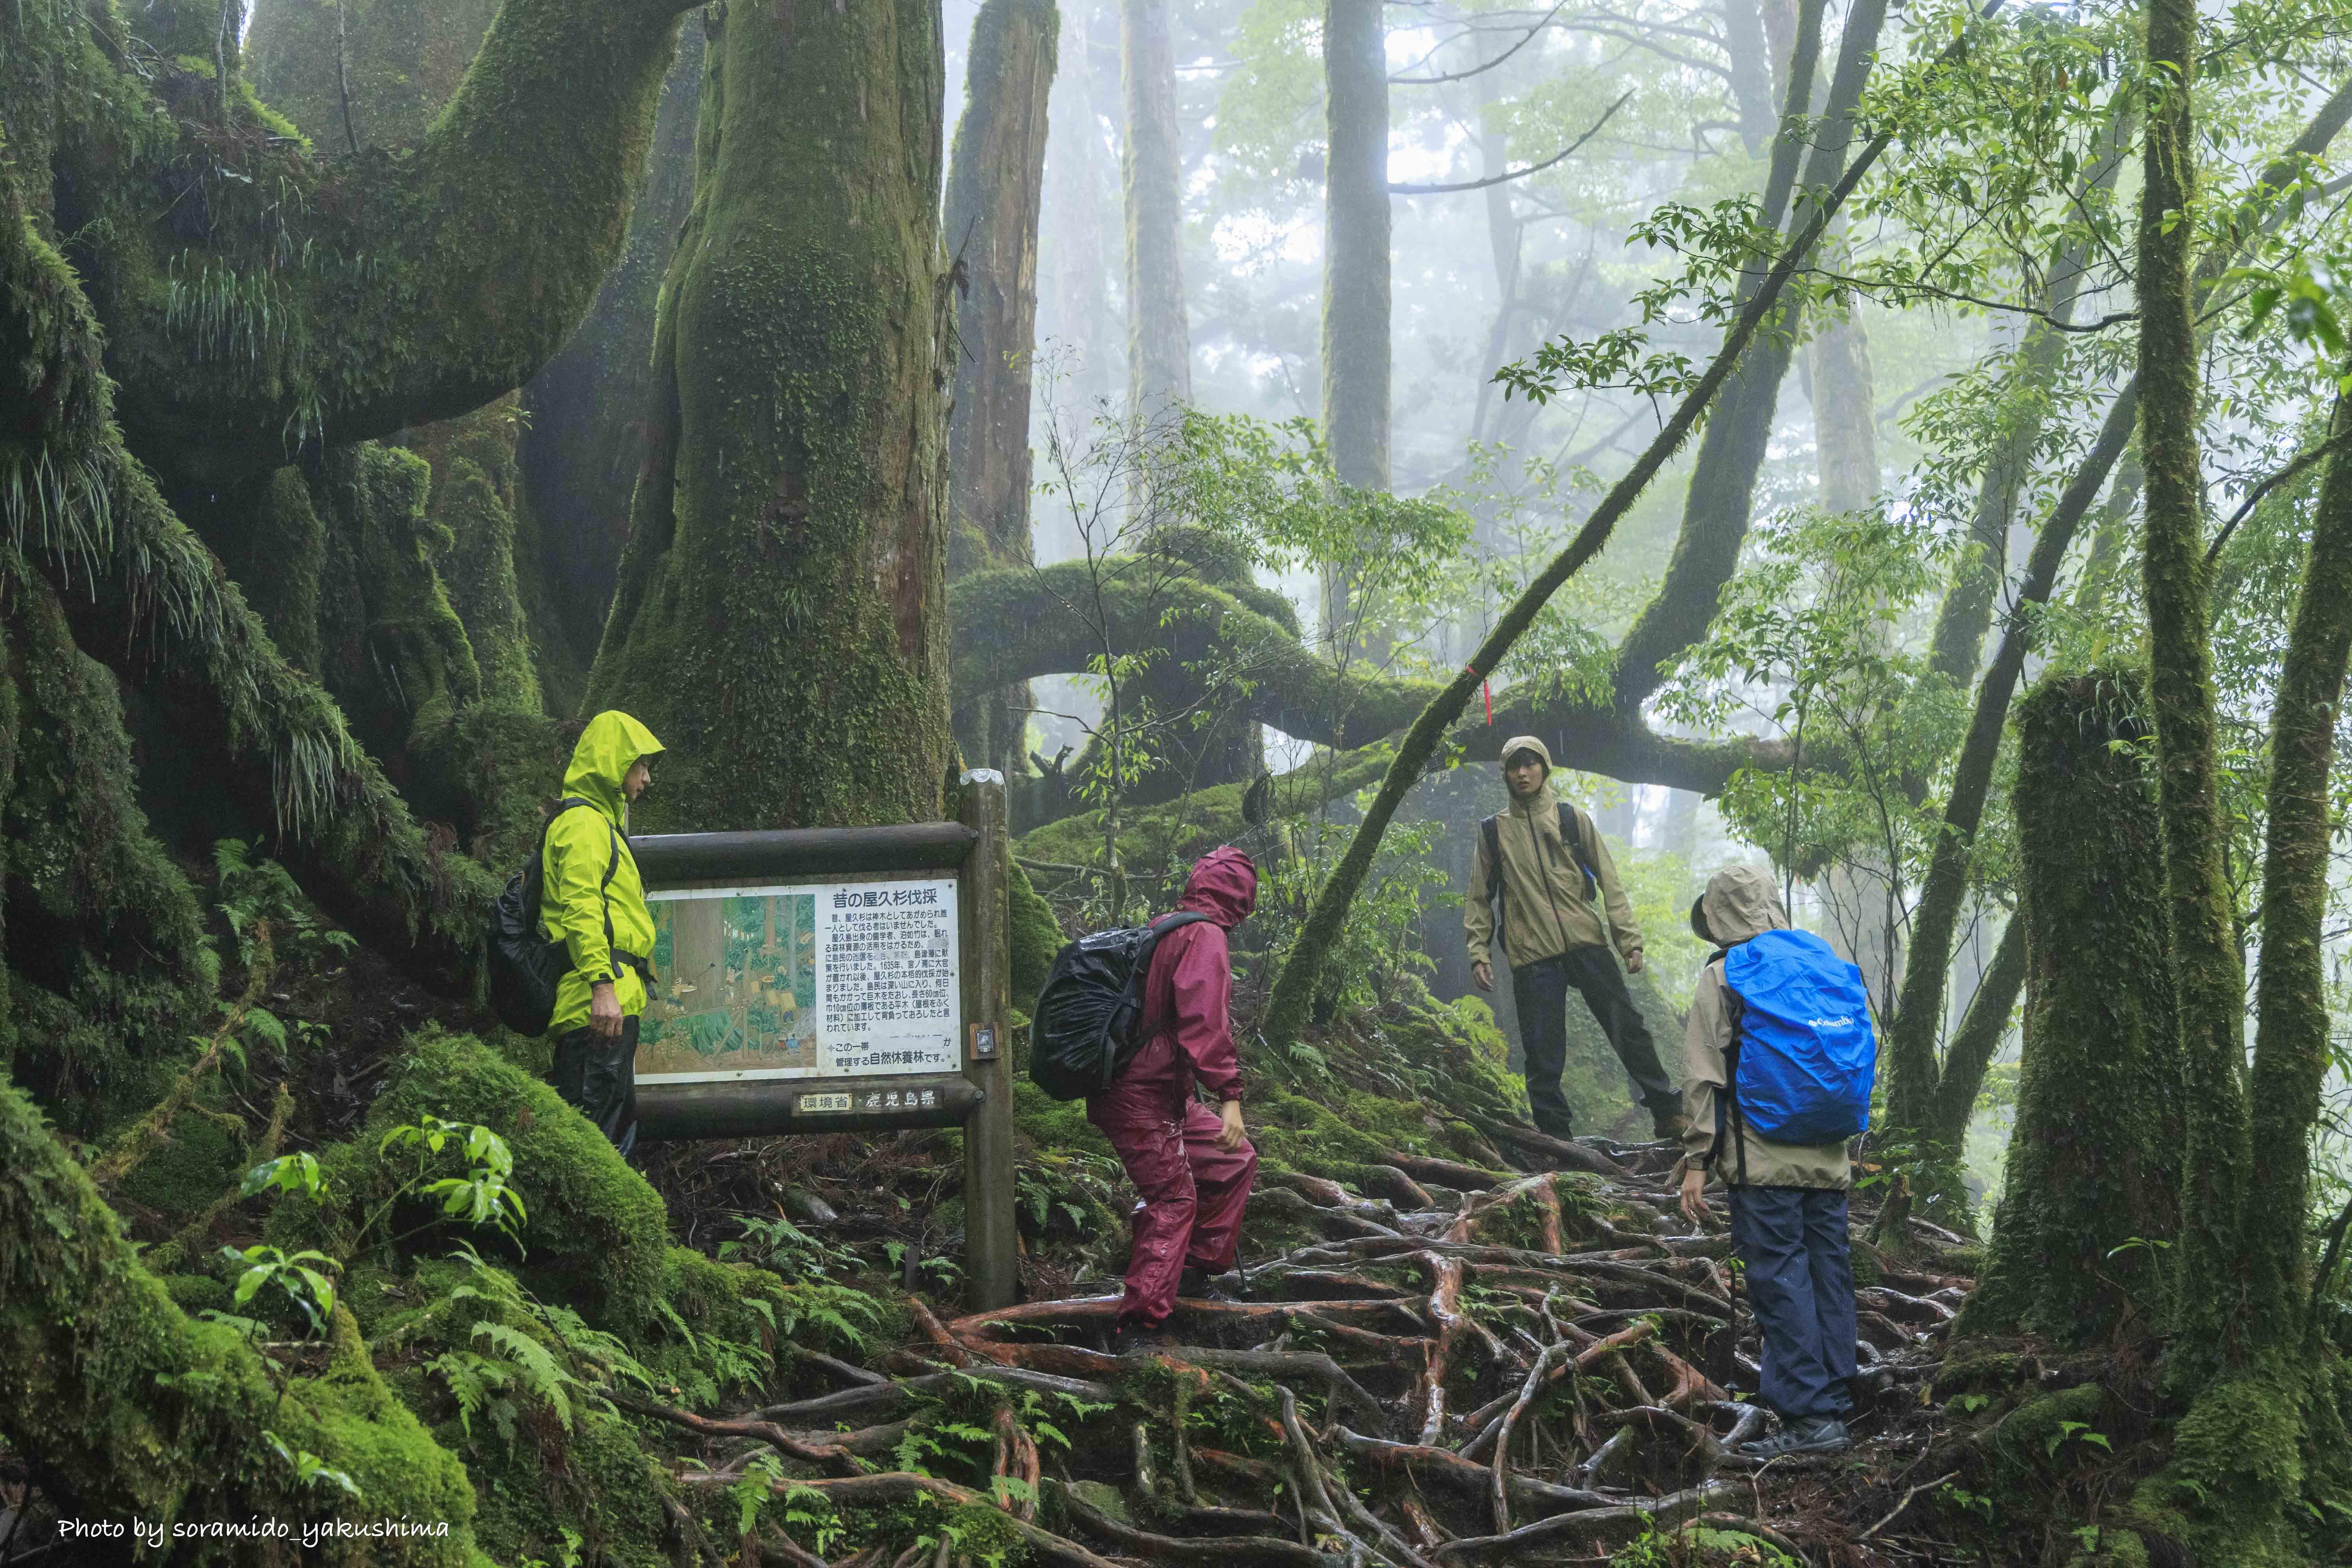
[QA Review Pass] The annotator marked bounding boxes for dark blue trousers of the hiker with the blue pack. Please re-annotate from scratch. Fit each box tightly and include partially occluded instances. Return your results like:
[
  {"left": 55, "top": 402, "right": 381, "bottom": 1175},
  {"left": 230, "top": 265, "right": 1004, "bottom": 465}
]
[{"left": 1731, "top": 1187, "right": 1853, "bottom": 1420}]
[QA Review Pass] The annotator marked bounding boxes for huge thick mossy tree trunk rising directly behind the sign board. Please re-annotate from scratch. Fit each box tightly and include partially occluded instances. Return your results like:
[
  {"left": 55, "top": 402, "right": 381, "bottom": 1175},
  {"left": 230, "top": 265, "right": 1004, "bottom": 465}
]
[{"left": 588, "top": 0, "right": 950, "bottom": 828}]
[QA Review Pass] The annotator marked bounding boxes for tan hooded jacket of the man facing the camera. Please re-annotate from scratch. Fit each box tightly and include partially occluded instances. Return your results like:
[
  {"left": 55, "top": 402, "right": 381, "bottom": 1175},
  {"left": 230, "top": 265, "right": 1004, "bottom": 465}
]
[{"left": 1463, "top": 736, "right": 1642, "bottom": 969}]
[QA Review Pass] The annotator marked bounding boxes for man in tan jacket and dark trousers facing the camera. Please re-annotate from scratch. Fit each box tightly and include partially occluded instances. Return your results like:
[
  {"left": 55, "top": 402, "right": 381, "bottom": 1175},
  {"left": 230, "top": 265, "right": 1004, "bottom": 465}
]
[{"left": 1463, "top": 736, "right": 1682, "bottom": 1138}]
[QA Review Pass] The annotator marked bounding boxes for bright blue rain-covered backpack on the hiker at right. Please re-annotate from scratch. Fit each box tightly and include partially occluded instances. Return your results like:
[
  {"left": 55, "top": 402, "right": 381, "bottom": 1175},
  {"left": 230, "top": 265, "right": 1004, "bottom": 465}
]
[{"left": 1724, "top": 931, "right": 1879, "bottom": 1145}]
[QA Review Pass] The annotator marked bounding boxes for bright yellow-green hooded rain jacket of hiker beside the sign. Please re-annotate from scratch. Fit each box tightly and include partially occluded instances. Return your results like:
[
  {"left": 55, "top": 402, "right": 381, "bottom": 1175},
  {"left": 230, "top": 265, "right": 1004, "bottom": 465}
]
[{"left": 539, "top": 710, "right": 663, "bottom": 1037}]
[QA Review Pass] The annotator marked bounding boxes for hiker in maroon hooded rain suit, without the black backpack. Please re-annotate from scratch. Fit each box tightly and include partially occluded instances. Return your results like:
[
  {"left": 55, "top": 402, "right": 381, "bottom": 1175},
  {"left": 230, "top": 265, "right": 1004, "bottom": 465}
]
[{"left": 1087, "top": 846, "right": 1258, "bottom": 1354}]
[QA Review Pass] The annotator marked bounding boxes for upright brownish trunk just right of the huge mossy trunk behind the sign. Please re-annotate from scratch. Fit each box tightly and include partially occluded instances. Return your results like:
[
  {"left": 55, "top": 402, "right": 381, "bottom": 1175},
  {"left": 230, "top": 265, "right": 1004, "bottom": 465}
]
[{"left": 946, "top": 0, "right": 1061, "bottom": 773}]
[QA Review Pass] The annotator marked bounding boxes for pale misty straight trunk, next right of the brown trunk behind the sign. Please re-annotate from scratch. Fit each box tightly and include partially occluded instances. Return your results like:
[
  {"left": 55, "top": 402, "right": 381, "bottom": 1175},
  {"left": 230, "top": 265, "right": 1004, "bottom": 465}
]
[{"left": 1120, "top": 0, "right": 1192, "bottom": 418}]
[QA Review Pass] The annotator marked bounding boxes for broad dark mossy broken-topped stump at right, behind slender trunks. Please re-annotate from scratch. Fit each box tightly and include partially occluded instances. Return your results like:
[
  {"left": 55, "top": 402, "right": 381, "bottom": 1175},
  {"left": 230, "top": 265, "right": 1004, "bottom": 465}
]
[{"left": 1962, "top": 675, "right": 2180, "bottom": 1345}]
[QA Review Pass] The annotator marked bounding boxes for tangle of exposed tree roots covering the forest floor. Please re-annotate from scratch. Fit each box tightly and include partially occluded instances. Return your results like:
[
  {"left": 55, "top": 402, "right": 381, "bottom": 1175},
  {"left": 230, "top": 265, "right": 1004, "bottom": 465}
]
[{"left": 630, "top": 1145, "right": 1969, "bottom": 1568}]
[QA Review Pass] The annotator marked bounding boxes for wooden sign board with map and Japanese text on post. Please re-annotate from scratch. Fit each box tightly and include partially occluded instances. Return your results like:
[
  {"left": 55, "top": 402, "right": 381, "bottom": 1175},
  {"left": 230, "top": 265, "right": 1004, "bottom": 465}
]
[{"left": 630, "top": 771, "right": 1016, "bottom": 1312}]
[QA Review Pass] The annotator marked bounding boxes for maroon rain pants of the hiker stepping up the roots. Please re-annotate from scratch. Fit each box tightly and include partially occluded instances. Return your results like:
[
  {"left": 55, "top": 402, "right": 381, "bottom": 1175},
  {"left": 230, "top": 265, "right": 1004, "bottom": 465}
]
[{"left": 1087, "top": 1100, "right": 1258, "bottom": 1328}]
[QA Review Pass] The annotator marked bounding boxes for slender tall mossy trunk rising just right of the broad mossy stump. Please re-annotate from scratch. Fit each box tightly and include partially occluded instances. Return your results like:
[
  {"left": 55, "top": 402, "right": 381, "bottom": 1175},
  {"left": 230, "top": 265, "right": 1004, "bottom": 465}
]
[{"left": 2138, "top": 0, "right": 2251, "bottom": 1368}]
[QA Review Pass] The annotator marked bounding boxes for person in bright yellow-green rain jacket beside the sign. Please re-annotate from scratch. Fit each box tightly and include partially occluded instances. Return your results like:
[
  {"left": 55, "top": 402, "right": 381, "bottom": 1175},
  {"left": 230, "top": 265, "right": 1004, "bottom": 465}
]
[{"left": 539, "top": 710, "right": 663, "bottom": 1157}]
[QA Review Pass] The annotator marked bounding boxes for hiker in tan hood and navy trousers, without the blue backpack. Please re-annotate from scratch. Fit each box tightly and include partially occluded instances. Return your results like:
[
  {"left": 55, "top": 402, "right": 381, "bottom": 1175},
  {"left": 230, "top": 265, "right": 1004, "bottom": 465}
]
[{"left": 1682, "top": 865, "right": 1853, "bottom": 1460}]
